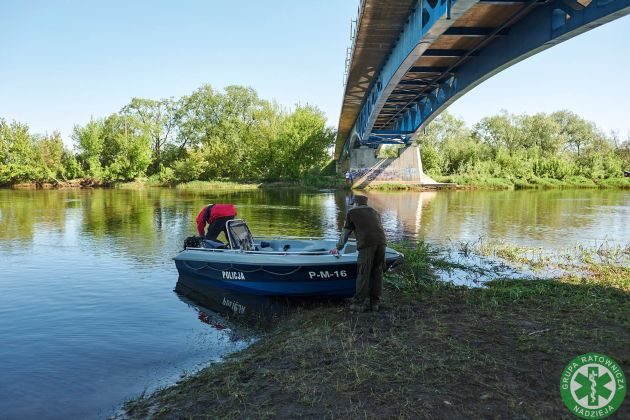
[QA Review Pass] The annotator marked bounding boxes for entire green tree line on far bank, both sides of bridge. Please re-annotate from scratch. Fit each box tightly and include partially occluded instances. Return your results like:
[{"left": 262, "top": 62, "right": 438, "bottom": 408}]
[{"left": 0, "top": 85, "right": 630, "bottom": 185}]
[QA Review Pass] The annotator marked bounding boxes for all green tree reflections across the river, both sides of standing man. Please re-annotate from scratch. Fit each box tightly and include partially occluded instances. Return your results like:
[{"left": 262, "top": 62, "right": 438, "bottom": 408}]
[{"left": 0, "top": 188, "right": 630, "bottom": 263}]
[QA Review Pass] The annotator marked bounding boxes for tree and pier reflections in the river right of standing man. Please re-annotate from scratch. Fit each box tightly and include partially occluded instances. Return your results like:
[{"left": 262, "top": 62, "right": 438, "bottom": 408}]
[{"left": 338, "top": 190, "right": 628, "bottom": 242}]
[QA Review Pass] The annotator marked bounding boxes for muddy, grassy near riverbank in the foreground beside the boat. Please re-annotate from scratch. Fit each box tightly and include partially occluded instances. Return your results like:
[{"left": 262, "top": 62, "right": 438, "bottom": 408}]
[{"left": 125, "top": 241, "right": 630, "bottom": 418}]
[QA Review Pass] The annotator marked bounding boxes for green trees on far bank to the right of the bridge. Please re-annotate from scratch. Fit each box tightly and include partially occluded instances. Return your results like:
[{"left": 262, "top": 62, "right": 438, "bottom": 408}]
[{"left": 420, "top": 111, "right": 630, "bottom": 180}]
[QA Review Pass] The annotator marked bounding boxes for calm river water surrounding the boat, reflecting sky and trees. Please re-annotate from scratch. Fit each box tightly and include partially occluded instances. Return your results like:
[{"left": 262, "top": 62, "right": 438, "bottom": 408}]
[{"left": 0, "top": 189, "right": 630, "bottom": 419}]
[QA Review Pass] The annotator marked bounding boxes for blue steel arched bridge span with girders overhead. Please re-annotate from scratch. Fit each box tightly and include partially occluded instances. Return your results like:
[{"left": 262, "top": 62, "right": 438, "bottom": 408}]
[{"left": 336, "top": 0, "right": 630, "bottom": 160}]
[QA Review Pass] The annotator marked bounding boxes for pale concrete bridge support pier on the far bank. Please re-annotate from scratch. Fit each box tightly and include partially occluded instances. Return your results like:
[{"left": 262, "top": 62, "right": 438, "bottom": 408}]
[{"left": 350, "top": 145, "right": 441, "bottom": 188}]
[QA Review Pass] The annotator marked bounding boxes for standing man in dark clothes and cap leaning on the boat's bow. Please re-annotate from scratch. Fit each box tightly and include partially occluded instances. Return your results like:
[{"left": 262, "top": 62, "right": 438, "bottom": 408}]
[{"left": 330, "top": 195, "right": 387, "bottom": 312}]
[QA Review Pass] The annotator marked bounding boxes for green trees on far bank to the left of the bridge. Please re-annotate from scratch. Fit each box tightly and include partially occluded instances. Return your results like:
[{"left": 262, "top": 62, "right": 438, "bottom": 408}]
[{"left": 0, "top": 85, "right": 335, "bottom": 185}]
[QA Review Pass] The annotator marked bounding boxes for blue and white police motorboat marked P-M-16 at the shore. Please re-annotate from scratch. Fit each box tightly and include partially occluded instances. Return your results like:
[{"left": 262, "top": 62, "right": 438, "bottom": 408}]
[{"left": 174, "top": 220, "right": 402, "bottom": 298}]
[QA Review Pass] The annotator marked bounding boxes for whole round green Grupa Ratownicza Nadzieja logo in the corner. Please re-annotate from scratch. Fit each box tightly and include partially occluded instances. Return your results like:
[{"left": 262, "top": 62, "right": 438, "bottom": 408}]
[{"left": 560, "top": 353, "right": 626, "bottom": 419}]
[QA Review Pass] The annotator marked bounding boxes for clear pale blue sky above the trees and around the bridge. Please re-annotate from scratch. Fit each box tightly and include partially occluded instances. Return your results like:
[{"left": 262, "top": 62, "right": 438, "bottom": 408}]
[{"left": 0, "top": 0, "right": 630, "bottom": 144}]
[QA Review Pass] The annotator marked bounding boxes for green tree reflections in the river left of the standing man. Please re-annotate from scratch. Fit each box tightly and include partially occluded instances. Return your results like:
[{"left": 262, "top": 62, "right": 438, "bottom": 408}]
[{"left": 0, "top": 188, "right": 334, "bottom": 259}]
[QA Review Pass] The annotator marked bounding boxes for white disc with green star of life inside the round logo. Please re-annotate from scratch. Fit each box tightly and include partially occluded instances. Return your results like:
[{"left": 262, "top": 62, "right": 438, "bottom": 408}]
[{"left": 570, "top": 363, "right": 615, "bottom": 409}]
